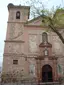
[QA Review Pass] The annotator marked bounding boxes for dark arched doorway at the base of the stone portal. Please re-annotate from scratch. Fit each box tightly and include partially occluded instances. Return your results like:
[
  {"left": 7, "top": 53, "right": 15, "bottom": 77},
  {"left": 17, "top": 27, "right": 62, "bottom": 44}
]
[{"left": 42, "top": 64, "right": 53, "bottom": 82}]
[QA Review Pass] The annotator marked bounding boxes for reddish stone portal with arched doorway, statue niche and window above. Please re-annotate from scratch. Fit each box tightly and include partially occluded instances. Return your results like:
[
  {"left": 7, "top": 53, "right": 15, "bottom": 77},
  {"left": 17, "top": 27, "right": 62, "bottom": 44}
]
[{"left": 36, "top": 32, "right": 58, "bottom": 82}]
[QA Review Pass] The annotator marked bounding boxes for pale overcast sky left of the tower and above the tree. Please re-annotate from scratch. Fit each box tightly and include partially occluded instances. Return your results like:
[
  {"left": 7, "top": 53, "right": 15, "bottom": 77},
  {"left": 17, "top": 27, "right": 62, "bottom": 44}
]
[{"left": 0, "top": 0, "right": 64, "bottom": 66}]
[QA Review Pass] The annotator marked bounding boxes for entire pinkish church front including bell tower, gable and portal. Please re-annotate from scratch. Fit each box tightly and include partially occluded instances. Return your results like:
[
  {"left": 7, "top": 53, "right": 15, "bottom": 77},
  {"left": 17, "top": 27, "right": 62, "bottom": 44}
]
[{"left": 2, "top": 4, "right": 64, "bottom": 82}]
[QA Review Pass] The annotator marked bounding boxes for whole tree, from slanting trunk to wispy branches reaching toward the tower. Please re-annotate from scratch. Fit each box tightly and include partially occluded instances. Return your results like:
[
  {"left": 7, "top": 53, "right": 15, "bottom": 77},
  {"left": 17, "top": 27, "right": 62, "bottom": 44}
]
[{"left": 28, "top": 0, "right": 64, "bottom": 44}]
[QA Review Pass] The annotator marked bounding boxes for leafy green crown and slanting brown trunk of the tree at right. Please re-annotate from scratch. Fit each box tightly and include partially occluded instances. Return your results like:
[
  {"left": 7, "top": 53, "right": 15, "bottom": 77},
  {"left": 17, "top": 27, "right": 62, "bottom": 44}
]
[{"left": 42, "top": 8, "right": 64, "bottom": 44}]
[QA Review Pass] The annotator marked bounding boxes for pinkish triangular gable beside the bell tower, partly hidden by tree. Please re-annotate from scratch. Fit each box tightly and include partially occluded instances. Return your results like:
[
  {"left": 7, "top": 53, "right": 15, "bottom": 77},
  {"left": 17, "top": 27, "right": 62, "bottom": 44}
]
[{"left": 25, "top": 16, "right": 43, "bottom": 26}]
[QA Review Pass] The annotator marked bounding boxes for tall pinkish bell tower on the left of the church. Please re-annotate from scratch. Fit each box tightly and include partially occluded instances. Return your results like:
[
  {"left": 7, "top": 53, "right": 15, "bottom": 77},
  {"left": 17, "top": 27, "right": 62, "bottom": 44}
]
[{"left": 2, "top": 3, "right": 30, "bottom": 73}]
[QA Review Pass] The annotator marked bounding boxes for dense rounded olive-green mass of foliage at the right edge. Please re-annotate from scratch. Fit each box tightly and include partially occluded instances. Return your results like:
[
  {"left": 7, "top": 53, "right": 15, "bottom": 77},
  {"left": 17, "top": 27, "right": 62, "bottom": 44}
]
[{"left": 53, "top": 8, "right": 64, "bottom": 28}]
